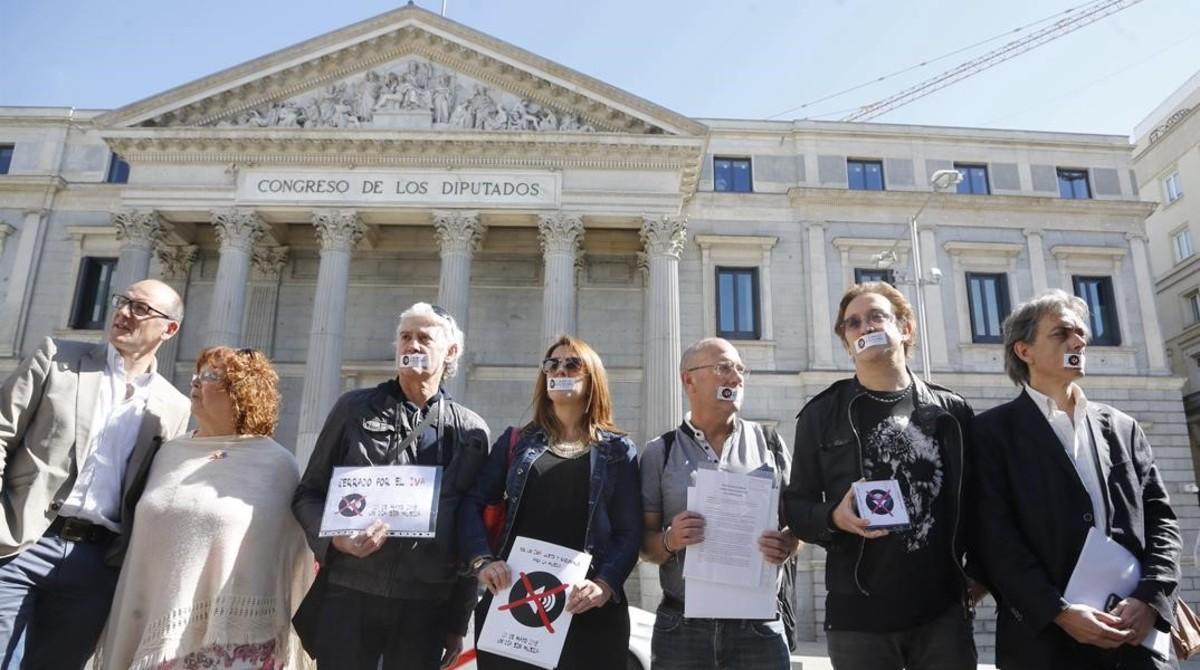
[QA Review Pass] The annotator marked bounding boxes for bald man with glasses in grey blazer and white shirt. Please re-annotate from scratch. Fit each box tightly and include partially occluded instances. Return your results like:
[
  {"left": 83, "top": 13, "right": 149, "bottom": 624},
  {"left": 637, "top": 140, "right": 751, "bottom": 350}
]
[{"left": 0, "top": 280, "right": 191, "bottom": 669}]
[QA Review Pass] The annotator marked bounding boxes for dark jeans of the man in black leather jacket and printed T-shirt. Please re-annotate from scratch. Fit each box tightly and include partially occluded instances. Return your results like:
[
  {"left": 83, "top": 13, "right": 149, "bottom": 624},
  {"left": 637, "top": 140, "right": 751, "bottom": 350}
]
[{"left": 827, "top": 605, "right": 978, "bottom": 670}]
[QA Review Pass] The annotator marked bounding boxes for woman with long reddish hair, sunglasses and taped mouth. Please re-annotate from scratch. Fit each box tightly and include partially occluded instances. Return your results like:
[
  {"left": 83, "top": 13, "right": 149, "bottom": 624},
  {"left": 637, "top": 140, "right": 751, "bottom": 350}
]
[{"left": 458, "top": 335, "right": 642, "bottom": 670}]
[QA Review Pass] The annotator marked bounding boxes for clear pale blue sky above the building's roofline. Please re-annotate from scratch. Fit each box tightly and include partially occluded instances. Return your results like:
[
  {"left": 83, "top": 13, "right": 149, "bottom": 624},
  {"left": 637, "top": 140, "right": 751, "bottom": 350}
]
[{"left": 0, "top": 0, "right": 1200, "bottom": 134}]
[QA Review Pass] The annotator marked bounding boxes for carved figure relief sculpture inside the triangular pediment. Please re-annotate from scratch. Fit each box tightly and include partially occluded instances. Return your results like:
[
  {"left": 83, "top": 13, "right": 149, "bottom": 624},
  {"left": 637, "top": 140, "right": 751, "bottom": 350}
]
[{"left": 211, "top": 60, "right": 595, "bottom": 132}]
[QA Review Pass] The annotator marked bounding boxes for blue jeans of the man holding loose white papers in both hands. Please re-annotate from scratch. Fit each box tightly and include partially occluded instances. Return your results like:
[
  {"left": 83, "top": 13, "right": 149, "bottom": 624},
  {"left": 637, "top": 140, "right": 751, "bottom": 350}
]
[{"left": 650, "top": 605, "right": 791, "bottom": 670}]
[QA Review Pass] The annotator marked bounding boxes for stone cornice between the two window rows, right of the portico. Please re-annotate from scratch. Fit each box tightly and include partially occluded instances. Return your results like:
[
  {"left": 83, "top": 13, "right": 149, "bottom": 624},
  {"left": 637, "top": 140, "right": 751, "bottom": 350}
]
[{"left": 787, "top": 186, "right": 1158, "bottom": 222}]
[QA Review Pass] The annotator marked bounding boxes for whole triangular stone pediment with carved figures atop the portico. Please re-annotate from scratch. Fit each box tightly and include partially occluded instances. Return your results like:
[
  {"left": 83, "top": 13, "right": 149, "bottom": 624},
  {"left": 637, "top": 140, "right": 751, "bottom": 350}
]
[{"left": 96, "top": 5, "right": 704, "bottom": 136}]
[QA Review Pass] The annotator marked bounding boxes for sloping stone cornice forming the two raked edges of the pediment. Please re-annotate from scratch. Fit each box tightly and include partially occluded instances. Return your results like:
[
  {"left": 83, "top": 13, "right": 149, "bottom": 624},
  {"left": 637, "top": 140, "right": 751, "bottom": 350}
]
[{"left": 97, "top": 5, "right": 706, "bottom": 134}]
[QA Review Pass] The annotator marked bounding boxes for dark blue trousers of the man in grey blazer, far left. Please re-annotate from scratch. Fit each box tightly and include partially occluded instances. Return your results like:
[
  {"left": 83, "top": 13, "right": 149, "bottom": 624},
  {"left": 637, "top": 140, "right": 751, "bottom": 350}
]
[{"left": 0, "top": 533, "right": 119, "bottom": 670}]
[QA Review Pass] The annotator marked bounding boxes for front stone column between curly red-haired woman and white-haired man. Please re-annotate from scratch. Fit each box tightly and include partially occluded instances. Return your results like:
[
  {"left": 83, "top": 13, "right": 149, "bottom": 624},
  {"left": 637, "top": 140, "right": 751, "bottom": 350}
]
[{"left": 296, "top": 209, "right": 366, "bottom": 469}]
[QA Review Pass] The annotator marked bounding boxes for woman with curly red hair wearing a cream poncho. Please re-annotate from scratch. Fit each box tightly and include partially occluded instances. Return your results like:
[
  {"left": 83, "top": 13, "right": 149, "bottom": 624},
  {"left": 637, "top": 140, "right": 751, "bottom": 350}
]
[{"left": 100, "top": 347, "right": 312, "bottom": 670}]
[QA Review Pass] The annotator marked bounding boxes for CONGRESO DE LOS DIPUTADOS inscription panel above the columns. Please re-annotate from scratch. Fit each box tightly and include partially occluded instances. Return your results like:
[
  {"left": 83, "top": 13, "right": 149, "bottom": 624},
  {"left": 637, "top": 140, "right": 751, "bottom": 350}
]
[{"left": 238, "top": 169, "right": 562, "bottom": 209}]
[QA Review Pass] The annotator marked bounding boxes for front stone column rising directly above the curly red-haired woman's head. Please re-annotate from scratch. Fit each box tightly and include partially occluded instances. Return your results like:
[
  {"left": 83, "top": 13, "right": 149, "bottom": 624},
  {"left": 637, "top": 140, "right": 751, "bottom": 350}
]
[{"left": 204, "top": 209, "right": 265, "bottom": 347}]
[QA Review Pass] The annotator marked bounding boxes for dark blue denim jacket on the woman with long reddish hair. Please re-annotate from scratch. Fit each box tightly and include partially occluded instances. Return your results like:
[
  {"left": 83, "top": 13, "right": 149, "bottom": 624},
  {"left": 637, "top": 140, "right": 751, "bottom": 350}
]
[{"left": 458, "top": 427, "right": 642, "bottom": 602}]
